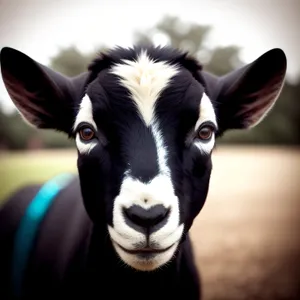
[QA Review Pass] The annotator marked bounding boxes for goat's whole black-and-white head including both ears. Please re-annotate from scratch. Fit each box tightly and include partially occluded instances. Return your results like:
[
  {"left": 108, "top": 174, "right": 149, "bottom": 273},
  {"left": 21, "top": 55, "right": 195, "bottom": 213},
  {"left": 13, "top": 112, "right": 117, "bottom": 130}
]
[{"left": 1, "top": 47, "right": 286, "bottom": 271}]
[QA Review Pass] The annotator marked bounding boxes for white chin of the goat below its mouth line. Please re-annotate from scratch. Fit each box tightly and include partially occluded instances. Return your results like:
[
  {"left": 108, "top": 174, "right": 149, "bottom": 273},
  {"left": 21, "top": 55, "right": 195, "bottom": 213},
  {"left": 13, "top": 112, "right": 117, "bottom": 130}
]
[{"left": 113, "top": 242, "right": 179, "bottom": 271}]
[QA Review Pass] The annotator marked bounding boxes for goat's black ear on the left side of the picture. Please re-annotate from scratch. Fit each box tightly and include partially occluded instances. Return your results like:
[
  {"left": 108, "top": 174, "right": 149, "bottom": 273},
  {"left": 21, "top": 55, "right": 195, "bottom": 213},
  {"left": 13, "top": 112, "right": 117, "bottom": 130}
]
[{"left": 0, "top": 47, "right": 87, "bottom": 133}]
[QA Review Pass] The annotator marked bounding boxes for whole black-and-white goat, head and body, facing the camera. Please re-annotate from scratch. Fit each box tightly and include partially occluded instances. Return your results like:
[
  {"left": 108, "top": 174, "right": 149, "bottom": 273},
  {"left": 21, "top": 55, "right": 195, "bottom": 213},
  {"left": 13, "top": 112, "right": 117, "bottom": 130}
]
[{"left": 0, "top": 46, "right": 286, "bottom": 300}]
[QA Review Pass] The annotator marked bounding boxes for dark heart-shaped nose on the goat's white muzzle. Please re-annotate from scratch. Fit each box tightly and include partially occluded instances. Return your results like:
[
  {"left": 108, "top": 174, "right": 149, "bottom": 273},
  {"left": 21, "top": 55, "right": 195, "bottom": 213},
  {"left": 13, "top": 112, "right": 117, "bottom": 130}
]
[{"left": 124, "top": 205, "right": 170, "bottom": 230}]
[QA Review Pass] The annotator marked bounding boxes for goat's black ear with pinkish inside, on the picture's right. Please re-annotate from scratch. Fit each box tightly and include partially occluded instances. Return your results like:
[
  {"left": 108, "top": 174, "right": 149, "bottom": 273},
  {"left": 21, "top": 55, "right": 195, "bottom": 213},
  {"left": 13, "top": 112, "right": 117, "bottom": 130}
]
[{"left": 208, "top": 48, "right": 287, "bottom": 131}]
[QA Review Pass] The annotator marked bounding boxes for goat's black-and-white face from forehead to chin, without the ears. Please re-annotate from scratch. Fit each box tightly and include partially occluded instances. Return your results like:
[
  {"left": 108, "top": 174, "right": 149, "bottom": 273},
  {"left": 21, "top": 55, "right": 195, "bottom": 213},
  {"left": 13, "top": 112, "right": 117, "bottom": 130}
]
[{"left": 74, "top": 51, "right": 217, "bottom": 270}]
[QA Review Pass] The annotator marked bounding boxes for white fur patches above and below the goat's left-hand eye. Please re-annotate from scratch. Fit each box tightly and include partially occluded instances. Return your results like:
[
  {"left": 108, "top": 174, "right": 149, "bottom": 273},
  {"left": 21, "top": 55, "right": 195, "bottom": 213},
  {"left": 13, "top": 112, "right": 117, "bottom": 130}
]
[{"left": 73, "top": 95, "right": 97, "bottom": 154}]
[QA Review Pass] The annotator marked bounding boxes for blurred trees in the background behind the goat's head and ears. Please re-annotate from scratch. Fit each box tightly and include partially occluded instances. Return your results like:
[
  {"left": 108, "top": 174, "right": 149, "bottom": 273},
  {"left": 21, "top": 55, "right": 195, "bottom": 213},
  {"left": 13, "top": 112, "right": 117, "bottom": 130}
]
[{"left": 0, "top": 16, "right": 300, "bottom": 149}]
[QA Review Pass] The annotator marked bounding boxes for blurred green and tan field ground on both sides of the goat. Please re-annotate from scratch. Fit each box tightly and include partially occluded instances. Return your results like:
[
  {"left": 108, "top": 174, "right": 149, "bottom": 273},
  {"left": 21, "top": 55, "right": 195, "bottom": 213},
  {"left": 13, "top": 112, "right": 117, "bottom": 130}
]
[{"left": 0, "top": 147, "right": 300, "bottom": 300}]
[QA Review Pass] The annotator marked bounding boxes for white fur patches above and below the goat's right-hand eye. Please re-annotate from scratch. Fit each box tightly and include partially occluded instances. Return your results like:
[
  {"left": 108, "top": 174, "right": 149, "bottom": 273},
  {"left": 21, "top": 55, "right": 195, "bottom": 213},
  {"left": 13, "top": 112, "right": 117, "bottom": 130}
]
[{"left": 194, "top": 93, "right": 218, "bottom": 154}]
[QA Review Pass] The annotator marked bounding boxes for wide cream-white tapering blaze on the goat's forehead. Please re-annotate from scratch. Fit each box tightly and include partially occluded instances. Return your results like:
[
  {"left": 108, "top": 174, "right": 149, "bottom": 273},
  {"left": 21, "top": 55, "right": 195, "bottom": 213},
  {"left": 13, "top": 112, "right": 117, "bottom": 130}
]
[{"left": 111, "top": 51, "right": 178, "bottom": 125}]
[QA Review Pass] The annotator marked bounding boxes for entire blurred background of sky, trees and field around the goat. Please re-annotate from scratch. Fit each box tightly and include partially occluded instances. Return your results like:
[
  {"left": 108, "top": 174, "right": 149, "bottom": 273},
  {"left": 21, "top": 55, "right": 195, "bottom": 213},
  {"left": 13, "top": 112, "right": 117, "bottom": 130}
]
[{"left": 0, "top": 0, "right": 300, "bottom": 300}]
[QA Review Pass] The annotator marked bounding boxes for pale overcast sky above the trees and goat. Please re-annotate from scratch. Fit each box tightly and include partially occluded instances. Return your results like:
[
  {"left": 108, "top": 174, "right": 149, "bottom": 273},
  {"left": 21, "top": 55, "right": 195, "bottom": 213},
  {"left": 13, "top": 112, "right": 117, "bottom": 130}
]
[{"left": 0, "top": 0, "right": 300, "bottom": 111}]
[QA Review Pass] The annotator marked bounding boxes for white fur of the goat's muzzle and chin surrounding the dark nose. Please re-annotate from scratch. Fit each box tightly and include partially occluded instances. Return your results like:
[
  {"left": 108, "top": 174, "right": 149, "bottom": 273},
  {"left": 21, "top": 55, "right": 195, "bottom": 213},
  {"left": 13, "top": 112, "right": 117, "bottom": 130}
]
[{"left": 108, "top": 174, "right": 184, "bottom": 271}]
